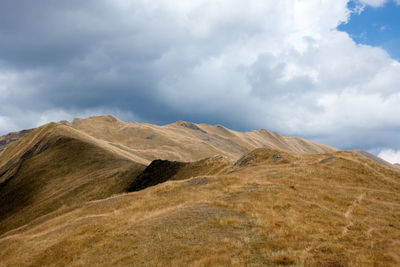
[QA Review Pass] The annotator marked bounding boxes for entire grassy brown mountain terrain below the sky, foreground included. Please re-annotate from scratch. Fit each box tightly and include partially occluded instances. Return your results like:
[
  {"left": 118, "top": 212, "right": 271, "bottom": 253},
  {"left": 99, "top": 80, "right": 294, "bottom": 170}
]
[{"left": 0, "top": 116, "right": 400, "bottom": 266}]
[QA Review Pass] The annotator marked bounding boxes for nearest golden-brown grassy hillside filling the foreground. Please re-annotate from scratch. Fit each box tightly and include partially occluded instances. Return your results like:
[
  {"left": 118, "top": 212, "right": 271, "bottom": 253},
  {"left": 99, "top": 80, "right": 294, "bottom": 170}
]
[{"left": 0, "top": 149, "right": 400, "bottom": 266}]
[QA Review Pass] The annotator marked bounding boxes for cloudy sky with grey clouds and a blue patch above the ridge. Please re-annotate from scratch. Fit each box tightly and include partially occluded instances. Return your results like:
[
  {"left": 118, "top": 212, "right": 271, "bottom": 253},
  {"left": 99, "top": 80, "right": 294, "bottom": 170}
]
[{"left": 0, "top": 0, "right": 400, "bottom": 162}]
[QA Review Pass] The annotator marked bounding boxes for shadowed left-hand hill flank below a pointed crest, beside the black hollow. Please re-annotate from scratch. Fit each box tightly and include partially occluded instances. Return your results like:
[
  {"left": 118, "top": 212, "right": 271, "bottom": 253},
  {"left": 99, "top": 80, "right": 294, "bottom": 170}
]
[{"left": 0, "top": 123, "right": 144, "bottom": 236}]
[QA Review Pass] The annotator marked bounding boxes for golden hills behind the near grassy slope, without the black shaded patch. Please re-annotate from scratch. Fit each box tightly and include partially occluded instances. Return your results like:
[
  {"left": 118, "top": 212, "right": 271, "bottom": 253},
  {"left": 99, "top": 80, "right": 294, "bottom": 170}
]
[{"left": 0, "top": 115, "right": 334, "bottom": 238}]
